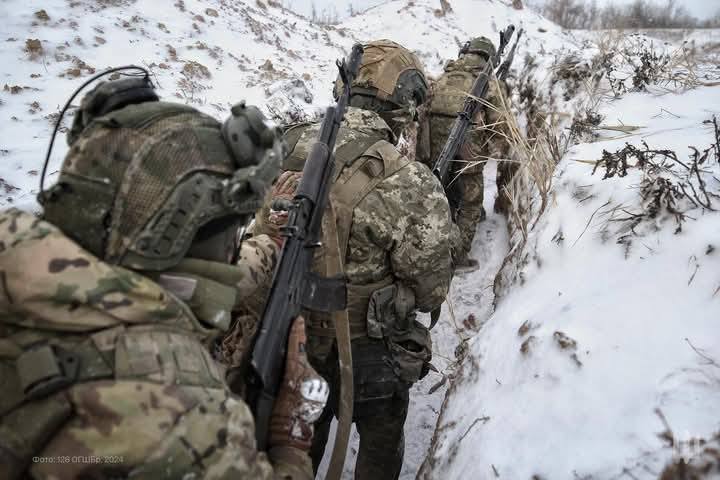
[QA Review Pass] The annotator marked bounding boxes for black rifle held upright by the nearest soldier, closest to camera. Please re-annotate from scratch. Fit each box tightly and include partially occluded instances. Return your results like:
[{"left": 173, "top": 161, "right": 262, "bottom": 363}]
[{"left": 247, "top": 44, "right": 363, "bottom": 450}]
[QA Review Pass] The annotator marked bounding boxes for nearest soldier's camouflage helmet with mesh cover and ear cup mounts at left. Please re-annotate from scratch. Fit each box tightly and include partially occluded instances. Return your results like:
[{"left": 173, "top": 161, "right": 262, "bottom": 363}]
[{"left": 38, "top": 82, "right": 283, "bottom": 270}]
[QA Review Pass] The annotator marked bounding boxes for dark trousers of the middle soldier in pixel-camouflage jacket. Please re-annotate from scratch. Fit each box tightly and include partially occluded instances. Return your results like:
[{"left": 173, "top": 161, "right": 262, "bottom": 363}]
[{"left": 310, "top": 338, "right": 410, "bottom": 480}]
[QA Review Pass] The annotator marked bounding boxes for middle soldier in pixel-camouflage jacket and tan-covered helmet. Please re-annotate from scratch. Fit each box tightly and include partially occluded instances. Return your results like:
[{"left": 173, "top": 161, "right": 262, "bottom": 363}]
[{"left": 255, "top": 40, "right": 451, "bottom": 480}]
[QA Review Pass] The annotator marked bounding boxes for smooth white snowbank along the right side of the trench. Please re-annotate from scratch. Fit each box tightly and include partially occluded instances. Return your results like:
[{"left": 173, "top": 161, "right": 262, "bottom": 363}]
[{"left": 427, "top": 58, "right": 720, "bottom": 479}]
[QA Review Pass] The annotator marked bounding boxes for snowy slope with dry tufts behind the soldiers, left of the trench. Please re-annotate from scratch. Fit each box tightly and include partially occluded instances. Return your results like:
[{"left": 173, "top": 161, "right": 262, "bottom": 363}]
[{"left": 0, "top": 0, "right": 570, "bottom": 208}]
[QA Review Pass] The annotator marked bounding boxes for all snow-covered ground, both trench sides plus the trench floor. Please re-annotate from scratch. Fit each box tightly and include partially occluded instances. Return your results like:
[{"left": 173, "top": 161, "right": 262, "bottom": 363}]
[{"left": 0, "top": 0, "right": 720, "bottom": 480}]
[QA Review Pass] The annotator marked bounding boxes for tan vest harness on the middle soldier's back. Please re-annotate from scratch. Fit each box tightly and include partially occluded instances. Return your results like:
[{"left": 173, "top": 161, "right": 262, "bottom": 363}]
[{"left": 284, "top": 118, "right": 410, "bottom": 338}]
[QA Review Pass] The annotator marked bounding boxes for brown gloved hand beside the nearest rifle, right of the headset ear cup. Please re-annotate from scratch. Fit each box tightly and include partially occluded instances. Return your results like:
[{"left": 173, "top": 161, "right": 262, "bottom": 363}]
[{"left": 253, "top": 171, "right": 302, "bottom": 246}]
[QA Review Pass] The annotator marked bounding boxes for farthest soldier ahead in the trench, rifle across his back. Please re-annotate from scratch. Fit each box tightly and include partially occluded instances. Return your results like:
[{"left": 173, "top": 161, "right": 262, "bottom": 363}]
[{"left": 419, "top": 37, "right": 516, "bottom": 269}]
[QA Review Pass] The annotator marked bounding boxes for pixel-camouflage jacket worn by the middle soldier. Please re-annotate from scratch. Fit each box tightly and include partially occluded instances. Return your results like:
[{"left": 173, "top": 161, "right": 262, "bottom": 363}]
[{"left": 268, "top": 107, "right": 451, "bottom": 320}]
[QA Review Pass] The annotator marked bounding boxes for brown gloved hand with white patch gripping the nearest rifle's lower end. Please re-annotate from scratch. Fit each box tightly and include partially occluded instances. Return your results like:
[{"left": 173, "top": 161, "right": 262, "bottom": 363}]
[{"left": 268, "top": 317, "right": 330, "bottom": 451}]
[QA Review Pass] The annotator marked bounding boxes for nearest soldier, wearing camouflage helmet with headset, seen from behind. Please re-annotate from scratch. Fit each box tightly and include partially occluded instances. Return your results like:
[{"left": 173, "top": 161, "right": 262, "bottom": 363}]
[{"left": 0, "top": 79, "right": 328, "bottom": 480}]
